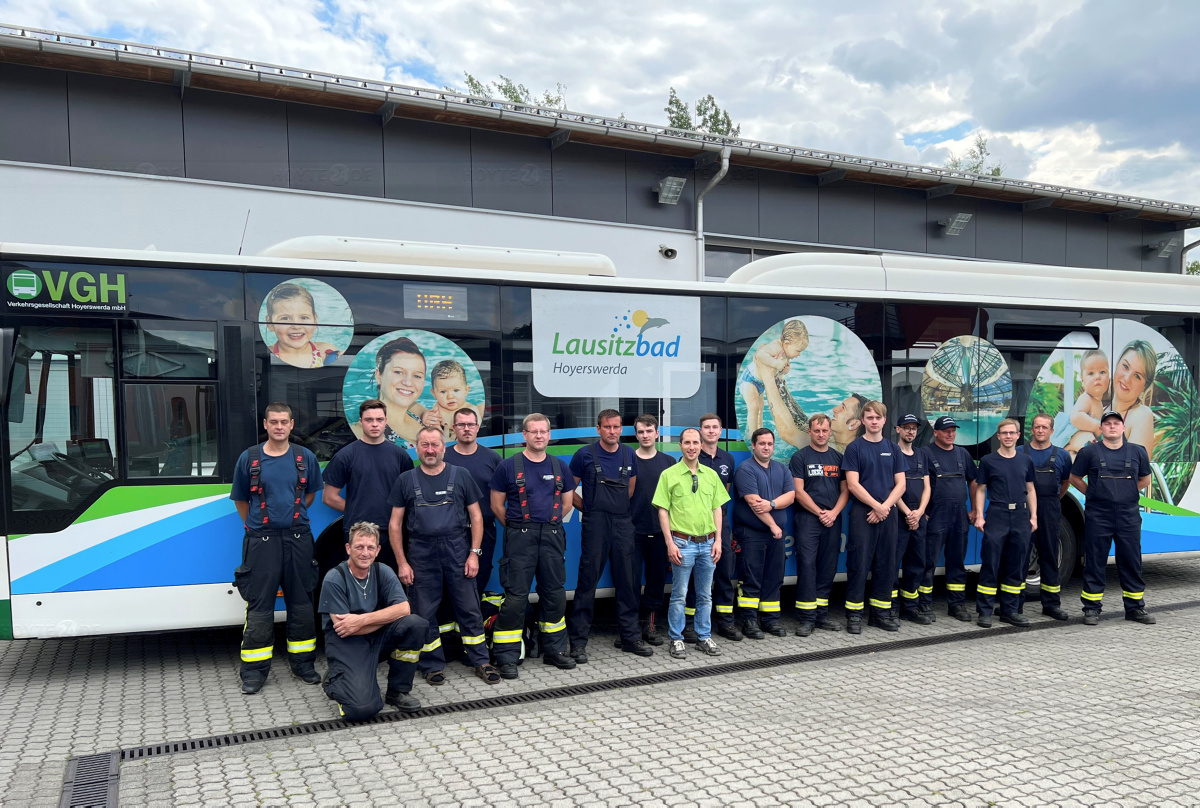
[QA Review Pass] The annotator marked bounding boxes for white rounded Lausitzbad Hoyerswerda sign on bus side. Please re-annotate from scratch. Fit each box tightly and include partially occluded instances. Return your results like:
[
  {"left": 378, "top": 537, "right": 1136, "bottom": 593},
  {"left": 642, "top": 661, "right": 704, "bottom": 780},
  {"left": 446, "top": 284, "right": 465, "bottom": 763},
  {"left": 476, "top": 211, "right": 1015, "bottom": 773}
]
[{"left": 532, "top": 289, "right": 700, "bottom": 399}]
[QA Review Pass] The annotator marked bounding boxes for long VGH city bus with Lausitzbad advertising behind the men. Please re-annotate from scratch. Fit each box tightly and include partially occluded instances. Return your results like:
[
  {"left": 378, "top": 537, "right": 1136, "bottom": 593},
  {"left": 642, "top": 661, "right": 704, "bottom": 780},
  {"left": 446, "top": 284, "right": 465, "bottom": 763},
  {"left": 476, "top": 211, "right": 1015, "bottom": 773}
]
[{"left": 0, "top": 237, "right": 1200, "bottom": 639}]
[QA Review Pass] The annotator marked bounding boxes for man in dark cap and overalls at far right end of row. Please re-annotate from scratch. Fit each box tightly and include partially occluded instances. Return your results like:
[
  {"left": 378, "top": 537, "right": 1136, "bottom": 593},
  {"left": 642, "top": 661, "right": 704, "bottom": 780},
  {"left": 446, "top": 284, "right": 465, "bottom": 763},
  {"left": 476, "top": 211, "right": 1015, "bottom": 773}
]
[{"left": 1070, "top": 409, "right": 1154, "bottom": 626}]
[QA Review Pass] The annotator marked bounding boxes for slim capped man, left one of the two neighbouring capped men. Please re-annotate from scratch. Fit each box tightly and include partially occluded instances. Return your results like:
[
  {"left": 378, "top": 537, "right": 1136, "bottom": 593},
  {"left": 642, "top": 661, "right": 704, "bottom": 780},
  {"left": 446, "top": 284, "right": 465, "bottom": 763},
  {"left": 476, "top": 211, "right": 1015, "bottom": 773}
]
[{"left": 892, "top": 413, "right": 937, "bottom": 626}]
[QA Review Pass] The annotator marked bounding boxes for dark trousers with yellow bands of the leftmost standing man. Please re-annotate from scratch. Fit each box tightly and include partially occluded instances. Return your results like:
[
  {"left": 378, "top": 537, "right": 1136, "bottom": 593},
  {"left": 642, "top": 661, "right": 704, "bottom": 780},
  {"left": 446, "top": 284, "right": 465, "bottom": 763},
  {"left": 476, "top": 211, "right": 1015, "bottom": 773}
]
[{"left": 233, "top": 526, "right": 318, "bottom": 678}]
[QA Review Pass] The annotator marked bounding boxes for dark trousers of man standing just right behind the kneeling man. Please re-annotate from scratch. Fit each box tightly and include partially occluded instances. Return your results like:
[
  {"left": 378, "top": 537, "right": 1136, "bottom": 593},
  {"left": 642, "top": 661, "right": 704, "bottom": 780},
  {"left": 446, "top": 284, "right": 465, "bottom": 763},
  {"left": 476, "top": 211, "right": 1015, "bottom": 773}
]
[{"left": 408, "top": 531, "right": 487, "bottom": 674}]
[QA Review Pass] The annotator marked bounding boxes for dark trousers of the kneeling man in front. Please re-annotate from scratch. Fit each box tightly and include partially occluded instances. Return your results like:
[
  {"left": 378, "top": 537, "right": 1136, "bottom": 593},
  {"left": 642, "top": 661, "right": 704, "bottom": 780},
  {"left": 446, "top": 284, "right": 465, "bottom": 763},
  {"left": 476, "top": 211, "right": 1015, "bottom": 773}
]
[{"left": 324, "top": 615, "right": 430, "bottom": 722}]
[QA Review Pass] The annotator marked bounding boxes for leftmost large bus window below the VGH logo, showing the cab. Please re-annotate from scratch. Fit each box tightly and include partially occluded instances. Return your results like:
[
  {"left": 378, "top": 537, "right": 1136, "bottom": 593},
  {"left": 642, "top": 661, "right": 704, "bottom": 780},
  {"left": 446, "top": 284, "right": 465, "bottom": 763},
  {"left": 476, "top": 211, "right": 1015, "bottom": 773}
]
[{"left": 7, "top": 327, "right": 116, "bottom": 516}]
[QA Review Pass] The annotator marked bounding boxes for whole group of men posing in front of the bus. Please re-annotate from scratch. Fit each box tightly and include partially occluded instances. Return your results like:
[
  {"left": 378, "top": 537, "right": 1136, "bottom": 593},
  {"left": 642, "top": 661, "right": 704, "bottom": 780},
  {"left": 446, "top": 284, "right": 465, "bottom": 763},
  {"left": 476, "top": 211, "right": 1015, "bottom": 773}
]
[{"left": 230, "top": 400, "right": 1154, "bottom": 720}]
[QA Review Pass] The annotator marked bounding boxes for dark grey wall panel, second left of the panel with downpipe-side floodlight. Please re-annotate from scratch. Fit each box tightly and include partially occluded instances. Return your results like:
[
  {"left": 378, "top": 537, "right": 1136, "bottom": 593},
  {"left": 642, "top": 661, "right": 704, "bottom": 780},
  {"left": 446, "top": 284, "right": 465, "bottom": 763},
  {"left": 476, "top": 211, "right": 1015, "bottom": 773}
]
[{"left": 470, "top": 128, "right": 554, "bottom": 215}]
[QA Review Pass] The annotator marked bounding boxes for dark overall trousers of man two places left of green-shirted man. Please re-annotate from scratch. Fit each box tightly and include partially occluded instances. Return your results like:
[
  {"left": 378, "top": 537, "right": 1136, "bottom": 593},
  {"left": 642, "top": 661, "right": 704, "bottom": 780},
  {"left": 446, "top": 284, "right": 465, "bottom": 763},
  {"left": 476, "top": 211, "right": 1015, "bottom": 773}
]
[{"left": 568, "top": 510, "right": 643, "bottom": 648}]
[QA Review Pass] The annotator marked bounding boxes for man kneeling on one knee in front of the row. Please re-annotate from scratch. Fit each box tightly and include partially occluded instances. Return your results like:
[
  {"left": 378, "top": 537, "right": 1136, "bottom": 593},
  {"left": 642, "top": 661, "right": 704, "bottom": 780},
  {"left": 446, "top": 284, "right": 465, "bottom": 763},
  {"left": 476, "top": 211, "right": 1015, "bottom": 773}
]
[{"left": 320, "top": 522, "right": 430, "bottom": 722}]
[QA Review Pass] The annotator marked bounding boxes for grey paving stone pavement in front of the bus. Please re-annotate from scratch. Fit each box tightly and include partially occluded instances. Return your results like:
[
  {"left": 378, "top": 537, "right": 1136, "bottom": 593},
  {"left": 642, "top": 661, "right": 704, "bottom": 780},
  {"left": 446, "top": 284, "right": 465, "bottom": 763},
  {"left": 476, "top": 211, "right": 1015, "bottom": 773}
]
[{"left": 7, "top": 559, "right": 1200, "bottom": 806}]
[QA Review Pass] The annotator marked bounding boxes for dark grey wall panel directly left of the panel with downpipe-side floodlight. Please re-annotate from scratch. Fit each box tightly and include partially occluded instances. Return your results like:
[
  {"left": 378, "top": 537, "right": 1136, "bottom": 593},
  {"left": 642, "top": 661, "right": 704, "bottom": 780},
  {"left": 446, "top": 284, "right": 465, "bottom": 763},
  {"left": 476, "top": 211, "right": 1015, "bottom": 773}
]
[{"left": 550, "top": 143, "right": 628, "bottom": 223}]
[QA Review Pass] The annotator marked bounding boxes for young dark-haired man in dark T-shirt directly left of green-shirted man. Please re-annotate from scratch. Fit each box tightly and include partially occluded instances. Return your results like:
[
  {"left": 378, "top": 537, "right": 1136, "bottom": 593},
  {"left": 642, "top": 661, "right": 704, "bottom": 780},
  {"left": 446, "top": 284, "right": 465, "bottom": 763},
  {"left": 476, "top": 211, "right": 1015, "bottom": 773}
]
[{"left": 617, "top": 413, "right": 676, "bottom": 646}]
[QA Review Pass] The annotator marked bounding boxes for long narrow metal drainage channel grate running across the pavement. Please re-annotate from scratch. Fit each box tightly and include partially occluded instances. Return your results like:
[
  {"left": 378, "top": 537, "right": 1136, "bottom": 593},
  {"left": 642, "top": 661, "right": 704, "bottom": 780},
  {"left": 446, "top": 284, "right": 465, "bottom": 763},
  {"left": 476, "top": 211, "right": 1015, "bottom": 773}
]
[{"left": 108, "top": 600, "right": 1200, "bottom": 763}]
